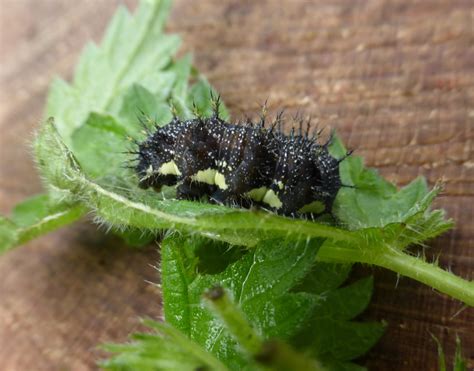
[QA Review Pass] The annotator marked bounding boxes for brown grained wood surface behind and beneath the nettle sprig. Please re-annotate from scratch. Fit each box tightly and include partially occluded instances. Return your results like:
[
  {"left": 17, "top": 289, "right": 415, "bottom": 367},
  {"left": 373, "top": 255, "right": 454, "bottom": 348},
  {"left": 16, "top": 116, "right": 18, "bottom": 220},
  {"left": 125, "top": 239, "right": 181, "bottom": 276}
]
[{"left": 0, "top": 0, "right": 474, "bottom": 370}]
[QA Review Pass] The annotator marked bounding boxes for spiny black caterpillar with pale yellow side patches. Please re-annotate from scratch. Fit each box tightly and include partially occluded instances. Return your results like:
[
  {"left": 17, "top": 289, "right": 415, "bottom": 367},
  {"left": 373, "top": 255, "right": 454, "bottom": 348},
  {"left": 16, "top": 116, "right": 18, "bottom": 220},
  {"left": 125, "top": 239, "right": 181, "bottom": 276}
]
[{"left": 133, "top": 97, "right": 350, "bottom": 217}]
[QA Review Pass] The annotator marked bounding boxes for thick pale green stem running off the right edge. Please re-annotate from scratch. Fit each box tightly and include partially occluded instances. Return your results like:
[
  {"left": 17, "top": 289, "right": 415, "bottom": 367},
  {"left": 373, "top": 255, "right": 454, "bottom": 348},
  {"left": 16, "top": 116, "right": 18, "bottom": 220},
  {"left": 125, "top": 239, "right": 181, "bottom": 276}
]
[{"left": 317, "top": 245, "right": 474, "bottom": 306}]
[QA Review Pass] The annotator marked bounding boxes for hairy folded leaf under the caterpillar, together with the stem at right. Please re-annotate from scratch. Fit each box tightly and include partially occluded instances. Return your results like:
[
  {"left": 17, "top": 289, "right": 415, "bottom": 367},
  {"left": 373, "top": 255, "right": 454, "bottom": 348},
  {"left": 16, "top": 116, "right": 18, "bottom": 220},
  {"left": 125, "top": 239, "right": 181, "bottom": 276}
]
[{"left": 36, "top": 111, "right": 474, "bottom": 303}]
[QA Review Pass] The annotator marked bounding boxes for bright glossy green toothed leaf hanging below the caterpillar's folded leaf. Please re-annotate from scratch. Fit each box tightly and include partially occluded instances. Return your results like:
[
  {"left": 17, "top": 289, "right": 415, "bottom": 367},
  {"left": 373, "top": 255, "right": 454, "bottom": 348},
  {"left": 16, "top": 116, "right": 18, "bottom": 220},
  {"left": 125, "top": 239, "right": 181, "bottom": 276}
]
[{"left": 161, "top": 237, "right": 322, "bottom": 368}]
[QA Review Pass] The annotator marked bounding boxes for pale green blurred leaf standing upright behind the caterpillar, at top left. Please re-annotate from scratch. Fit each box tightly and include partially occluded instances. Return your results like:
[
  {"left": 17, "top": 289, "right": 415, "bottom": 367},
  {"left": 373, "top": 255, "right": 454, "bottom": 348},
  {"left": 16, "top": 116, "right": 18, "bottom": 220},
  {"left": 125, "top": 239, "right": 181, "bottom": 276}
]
[{"left": 46, "top": 0, "right": 180, "bottom": 144}]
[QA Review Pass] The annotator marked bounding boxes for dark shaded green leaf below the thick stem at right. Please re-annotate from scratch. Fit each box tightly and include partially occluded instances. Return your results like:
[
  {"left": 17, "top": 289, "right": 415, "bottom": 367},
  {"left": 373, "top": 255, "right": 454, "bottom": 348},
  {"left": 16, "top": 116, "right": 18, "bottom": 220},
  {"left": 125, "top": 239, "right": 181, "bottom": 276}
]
[{"left": 292, "top": 262, "right": 384, "bottom": 370}]
